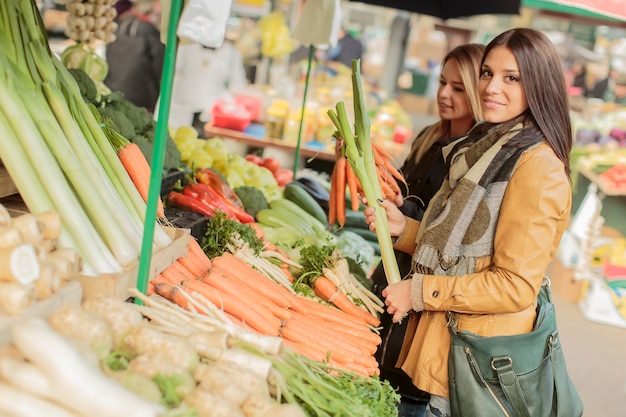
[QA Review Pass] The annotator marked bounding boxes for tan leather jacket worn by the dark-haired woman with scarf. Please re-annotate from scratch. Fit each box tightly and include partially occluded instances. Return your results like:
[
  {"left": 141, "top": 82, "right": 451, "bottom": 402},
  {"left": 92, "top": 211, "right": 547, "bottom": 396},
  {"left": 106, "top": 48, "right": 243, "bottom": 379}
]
[{"left": 395, "top": 143, "right": 572, "bottom": 397}]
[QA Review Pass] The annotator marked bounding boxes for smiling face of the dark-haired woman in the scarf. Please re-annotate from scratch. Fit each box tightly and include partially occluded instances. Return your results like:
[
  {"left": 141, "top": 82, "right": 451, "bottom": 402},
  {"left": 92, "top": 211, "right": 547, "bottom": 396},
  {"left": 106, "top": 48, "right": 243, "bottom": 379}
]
[{"left": 478, "top": 46, "right": 528, "bottom": 123}]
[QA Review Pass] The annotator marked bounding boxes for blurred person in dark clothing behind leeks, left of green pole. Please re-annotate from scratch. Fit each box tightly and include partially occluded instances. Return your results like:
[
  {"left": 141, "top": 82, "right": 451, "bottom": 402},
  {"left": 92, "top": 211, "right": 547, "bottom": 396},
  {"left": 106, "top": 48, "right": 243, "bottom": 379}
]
[{"left": 104, "top": 0, "right": 165, "bottom": 112}]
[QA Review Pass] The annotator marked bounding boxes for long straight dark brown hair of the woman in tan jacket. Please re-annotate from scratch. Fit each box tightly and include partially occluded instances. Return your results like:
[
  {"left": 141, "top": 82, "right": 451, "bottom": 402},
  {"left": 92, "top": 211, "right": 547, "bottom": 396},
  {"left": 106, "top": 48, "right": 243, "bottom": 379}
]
[{"left": 483, "top": 28, "right": 573, "bottom": 175}]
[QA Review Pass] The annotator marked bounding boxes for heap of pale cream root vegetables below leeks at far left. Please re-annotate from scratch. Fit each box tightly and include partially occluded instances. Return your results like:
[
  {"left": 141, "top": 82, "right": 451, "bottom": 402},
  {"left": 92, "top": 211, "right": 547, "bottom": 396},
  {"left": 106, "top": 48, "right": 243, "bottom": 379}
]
[{"left": 0, "top": 205, "right": 82, "bottom": 316}]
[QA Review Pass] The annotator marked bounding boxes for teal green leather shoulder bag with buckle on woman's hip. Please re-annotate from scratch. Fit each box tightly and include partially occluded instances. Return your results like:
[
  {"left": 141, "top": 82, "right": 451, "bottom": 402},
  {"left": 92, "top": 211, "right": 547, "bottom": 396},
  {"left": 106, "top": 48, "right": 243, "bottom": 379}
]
[{"left": 448, "top": 278, "right": 583, "bottom": 417}]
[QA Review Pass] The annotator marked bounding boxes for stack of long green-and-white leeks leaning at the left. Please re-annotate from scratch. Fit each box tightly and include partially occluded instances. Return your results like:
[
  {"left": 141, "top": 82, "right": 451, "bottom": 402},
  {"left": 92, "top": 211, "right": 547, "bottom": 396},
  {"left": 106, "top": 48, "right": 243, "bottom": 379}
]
[{"left": 0, "top": 0, "right": 172, "bottom": 276}]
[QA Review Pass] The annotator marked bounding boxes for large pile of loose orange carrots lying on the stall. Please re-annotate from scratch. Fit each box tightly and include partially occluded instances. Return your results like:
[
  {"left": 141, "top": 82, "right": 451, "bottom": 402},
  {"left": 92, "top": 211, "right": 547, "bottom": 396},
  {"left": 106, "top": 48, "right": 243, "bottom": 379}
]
[{"left": 150, "top": 247, "right": 381, "bottom": 376}]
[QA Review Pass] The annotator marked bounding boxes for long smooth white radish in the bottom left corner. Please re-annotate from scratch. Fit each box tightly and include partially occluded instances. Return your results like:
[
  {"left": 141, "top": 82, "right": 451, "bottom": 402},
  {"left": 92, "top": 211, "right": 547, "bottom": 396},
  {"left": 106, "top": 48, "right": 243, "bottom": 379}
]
[{"left": 10, "top": 318, "right": 164, "bottom": 417}]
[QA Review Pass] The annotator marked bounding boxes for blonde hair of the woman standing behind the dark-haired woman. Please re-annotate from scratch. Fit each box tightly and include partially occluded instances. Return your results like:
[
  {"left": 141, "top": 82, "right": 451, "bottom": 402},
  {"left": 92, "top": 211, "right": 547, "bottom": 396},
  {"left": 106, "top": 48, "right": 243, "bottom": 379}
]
[{"left": 409, "top": 43, "right": 485, "bottom": 163}]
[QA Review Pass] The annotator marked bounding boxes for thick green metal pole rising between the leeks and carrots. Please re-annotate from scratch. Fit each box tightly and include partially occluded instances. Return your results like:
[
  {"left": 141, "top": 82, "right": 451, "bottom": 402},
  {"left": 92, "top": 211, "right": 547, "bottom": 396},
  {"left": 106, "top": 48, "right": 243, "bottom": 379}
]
[{"left": 135, "top": 0, "right": 183, "bottom": 304}]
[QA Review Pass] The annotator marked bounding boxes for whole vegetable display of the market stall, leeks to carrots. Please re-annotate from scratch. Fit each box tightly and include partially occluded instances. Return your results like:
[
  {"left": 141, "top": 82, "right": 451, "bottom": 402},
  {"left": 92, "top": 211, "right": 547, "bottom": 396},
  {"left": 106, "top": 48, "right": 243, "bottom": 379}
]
[{"left": 0, "top": 0, "right": 398, "bottom": 417}]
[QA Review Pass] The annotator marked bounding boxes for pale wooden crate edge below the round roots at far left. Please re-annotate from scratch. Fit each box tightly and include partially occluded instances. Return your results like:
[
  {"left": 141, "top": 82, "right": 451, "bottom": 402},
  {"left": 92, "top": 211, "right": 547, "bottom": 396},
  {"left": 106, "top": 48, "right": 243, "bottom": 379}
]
[{"left": 0, "top": 281, "right": 82, "bottom": 346}]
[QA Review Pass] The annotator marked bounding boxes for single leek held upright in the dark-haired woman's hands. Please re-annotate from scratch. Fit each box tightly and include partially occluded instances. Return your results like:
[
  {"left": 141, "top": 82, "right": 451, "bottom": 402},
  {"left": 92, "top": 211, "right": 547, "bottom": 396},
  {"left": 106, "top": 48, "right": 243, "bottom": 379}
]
[{"left": 328, "top": 59, "right": 402, "bottom": 284}]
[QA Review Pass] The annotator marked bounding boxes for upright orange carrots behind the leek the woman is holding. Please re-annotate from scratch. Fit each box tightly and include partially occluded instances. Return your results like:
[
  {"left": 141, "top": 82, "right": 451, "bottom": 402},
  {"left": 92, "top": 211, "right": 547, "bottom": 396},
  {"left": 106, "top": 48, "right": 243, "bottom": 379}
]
[{"left": 328, "top": 144, "right": 406, "bottom": 227}]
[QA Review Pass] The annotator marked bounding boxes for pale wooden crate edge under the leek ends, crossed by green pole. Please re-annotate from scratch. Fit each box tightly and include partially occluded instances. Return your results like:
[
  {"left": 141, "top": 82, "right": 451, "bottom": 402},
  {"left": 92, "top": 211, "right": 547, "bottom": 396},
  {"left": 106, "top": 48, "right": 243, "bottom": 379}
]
[{"left": 79, "top": 227, "right": 190, "bottom": 300}]
